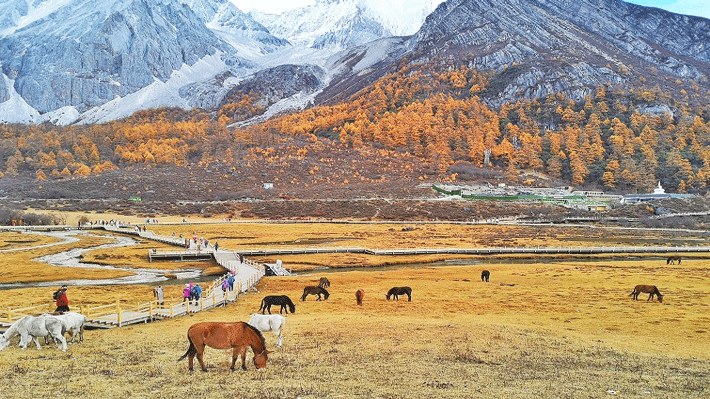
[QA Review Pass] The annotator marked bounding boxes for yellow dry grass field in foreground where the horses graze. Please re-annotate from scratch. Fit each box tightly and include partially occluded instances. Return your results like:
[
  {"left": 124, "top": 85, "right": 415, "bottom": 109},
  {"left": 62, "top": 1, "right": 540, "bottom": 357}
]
[{"left": 0, "top": 225, "right": 710, "bottom": 398}]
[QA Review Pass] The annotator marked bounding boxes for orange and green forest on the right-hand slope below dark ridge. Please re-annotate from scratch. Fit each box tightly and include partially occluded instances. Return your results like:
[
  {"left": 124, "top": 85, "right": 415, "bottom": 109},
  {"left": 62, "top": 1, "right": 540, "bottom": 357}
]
[{"left": 266, "top": 61, "right": 710, "bottom": 192}]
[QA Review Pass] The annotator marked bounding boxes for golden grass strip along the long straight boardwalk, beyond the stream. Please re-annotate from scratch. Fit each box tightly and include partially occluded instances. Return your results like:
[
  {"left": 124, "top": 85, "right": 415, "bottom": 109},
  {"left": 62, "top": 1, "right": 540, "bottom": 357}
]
[{"left": 149, "top": 222, "right": 707, "bottom": 271}]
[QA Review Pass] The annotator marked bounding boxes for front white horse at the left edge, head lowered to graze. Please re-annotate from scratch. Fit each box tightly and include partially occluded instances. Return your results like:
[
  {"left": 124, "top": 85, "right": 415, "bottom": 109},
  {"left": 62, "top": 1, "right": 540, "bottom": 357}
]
[{"left": 0, "top": 315, "right": 67, "bottom": 351}]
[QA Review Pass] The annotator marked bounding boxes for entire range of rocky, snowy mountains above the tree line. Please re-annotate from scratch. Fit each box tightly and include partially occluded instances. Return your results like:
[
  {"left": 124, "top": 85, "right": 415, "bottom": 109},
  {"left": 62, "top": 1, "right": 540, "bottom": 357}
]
[{"left": 0, "top": 0, "right": 710, "bottom": 124}]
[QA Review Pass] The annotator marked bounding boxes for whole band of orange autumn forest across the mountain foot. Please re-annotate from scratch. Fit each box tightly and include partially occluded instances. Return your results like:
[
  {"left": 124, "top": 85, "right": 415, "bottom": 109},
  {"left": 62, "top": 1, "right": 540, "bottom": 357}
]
[{"left": 0, "top": 59, "right": 710, "bottom": 192}]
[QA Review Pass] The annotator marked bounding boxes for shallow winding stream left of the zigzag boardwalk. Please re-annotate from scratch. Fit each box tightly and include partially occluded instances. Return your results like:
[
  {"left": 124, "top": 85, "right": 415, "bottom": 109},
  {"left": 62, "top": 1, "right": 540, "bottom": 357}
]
[{"left": 0, "top": 231, "right": 209, "bottom": 289}]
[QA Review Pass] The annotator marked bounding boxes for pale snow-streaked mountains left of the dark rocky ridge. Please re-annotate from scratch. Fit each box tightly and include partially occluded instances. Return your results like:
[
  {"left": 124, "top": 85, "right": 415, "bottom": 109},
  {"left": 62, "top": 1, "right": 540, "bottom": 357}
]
[{"left": 0, "top": 0, "right": 440, "bottom": 124}]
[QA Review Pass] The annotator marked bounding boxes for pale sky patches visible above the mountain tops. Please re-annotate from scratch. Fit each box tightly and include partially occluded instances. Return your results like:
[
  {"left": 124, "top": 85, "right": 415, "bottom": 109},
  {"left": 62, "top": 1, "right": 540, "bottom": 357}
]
[{"left": 230, "top": 0, "right": 710, "bottom": 19}]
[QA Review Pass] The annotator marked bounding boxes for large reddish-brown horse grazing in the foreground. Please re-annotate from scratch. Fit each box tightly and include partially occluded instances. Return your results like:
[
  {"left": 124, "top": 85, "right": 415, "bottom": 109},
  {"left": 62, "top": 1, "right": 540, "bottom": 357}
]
[{"left": 178, "top": 321, "right": 271, "bottom": 371}]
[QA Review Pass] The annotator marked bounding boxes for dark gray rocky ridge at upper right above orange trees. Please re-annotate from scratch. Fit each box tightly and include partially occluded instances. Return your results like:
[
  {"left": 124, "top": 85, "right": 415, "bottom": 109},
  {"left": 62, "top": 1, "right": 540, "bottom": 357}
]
[{"left": 410, "top": 0, "right": 710, "bottom": 105}]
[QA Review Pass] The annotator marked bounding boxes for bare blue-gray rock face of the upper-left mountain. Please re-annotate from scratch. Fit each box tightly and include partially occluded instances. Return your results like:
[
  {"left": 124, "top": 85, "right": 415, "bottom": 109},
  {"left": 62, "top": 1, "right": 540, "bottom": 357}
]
[{"left": 0, "top": 0, "right": 229, "bottom": 112}]
